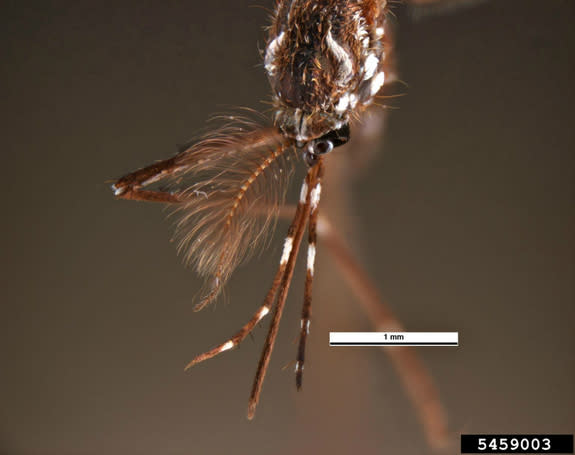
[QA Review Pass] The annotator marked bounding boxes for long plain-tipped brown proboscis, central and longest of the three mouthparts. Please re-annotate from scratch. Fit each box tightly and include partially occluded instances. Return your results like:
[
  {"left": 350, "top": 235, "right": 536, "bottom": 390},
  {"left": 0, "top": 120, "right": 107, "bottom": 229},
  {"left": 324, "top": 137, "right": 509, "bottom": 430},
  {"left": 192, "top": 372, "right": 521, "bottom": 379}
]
[{"left": 248, "top": 158, "right": 321, "bottom": 420}]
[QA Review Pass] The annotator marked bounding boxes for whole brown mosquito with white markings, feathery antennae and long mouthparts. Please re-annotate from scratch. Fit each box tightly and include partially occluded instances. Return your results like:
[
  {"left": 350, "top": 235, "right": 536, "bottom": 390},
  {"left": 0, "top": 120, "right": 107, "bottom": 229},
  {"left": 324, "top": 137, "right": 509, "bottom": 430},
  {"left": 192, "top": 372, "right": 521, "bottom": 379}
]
[{"left": 112, "top": 0, "right": 452, "bottom": 446}]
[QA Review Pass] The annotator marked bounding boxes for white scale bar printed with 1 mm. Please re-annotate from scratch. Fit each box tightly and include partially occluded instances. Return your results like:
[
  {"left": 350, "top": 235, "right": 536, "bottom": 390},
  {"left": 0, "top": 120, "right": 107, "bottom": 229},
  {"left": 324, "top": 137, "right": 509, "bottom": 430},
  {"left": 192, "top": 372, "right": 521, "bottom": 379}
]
[{"left": 329, "top": 332, "right": 459, "bottom": 346}]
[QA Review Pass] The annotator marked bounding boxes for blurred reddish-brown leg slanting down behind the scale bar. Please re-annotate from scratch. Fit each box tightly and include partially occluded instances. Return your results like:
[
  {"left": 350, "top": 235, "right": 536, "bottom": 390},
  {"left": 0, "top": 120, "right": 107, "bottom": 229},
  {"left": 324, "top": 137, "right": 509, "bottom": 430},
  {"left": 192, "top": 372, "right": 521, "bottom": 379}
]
[{"left": 317, "top": 217, "right": 449, "bottom": 448}]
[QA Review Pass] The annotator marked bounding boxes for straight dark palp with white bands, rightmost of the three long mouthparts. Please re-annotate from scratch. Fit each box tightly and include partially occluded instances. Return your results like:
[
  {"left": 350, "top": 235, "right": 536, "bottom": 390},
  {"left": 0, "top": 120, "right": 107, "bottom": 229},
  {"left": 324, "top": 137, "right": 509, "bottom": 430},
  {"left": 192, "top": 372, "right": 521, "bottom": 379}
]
[{"left": 295, "top": 159, "right": 323, "bottom": 390}]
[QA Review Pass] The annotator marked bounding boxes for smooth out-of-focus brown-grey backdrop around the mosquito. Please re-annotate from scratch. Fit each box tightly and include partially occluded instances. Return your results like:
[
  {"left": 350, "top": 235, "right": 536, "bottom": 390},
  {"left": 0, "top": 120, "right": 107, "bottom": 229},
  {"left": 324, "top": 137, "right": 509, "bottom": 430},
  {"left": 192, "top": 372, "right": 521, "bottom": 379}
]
[{"left": 0, "top": 0, "right": 575, "bottom": 455}]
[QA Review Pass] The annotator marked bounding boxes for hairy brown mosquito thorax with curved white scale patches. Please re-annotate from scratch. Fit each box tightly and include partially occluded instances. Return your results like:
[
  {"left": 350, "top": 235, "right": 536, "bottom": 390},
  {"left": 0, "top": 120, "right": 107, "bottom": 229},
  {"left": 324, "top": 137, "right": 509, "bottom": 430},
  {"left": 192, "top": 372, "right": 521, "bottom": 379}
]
[{"left": 264, "top": 0, "right": 390, "bottom": 146}]
